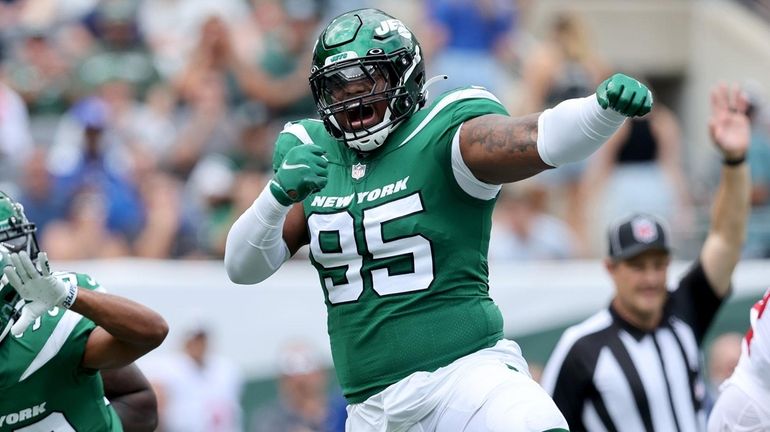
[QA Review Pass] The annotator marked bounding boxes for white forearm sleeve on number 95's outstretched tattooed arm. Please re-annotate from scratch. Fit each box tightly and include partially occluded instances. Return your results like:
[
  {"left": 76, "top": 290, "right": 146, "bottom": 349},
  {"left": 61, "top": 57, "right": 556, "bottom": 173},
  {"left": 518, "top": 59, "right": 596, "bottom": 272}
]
[{"left": 537, "top": 94, "right": 626, "bottom": 167}]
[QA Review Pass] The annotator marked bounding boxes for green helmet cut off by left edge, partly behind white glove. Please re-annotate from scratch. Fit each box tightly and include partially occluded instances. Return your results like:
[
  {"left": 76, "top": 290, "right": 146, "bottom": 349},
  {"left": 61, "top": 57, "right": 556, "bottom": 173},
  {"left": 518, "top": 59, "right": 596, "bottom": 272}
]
[{"left": 0, "top": 192, "right": 40, "bottom": 341}]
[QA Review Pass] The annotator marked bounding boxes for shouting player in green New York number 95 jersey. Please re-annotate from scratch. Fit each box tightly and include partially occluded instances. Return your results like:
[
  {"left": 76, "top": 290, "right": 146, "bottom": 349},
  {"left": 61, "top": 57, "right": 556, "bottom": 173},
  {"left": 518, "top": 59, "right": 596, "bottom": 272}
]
[{"left": 225, "top": 9, "right": 652, "bottom": 432}]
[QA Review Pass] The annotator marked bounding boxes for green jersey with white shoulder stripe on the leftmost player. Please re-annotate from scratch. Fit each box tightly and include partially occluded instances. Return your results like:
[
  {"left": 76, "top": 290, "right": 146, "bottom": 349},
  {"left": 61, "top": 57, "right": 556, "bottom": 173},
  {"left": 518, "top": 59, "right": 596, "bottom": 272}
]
[{"left": 0, "top": 273, "right": 123, "bottom": 432}]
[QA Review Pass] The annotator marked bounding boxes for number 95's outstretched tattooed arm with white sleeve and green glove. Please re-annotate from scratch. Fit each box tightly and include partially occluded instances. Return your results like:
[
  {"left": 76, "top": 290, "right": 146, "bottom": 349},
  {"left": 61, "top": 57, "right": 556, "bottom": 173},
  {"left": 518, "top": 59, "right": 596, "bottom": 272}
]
[{"left": 460, "top": 74, "right": 652, "bottom": 184}]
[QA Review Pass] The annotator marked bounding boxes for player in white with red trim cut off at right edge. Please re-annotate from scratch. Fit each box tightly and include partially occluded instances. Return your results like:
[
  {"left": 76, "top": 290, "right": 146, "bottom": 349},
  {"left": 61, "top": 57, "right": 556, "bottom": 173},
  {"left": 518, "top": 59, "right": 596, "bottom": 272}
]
[{"left": 708, "top": 289, "right": 770, "bottom": 432}]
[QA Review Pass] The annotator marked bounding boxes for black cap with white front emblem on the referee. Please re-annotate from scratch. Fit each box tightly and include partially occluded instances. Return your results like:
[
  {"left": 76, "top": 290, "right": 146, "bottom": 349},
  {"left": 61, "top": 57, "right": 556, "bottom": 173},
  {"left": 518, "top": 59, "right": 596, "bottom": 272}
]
[{"left": 607, "top": 213, "right": 671, "bottom": 261}]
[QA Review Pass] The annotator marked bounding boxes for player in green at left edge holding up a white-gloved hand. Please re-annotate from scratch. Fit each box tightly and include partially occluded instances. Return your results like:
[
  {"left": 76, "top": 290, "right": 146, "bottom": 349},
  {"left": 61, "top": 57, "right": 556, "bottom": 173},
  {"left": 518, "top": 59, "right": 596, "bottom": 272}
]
[{"left": 0, "top": 192, "right": 168, "bottom": 432}]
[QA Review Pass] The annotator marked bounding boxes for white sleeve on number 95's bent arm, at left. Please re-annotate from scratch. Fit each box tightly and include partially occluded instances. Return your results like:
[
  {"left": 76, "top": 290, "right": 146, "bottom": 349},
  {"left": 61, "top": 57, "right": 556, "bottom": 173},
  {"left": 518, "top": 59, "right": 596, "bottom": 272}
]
[{"left": 225, "top": 186, "right": 291, "bottom": 284}]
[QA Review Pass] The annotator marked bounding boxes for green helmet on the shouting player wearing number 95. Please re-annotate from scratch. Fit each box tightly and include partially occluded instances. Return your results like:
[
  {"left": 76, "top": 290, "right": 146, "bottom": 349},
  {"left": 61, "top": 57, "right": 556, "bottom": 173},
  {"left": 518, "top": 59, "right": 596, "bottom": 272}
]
[{"left": 310, "top": 9, "right": 425, "bottom": 152}]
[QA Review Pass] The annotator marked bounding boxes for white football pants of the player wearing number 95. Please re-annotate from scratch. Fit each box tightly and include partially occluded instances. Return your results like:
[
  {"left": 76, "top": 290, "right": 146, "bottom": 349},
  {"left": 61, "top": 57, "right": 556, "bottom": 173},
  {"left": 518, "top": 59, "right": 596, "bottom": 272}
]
[{"left": 345, "top": 339, "right": 568, "bottom": 432}]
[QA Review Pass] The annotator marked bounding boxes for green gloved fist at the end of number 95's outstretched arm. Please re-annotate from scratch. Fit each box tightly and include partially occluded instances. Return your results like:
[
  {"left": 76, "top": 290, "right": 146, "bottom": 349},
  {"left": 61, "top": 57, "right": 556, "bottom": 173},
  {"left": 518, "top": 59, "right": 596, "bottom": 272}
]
[{"left": 596, "top": 74, "right": 652, "bottom": 117}]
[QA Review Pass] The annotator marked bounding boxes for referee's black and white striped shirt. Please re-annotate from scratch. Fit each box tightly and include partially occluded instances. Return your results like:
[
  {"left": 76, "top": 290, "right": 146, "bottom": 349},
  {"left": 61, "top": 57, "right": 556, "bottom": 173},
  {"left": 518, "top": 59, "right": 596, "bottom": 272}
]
[{"left": 542, "top": 262, "right": 722, "bottom": 432}]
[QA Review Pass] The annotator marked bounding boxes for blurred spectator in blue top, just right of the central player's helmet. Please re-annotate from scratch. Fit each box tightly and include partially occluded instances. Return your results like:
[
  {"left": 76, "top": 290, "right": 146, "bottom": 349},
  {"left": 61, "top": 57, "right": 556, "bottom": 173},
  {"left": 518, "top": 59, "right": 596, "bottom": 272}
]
[{"left": 426, "top": 0, "right": 517, "bottom": 96}]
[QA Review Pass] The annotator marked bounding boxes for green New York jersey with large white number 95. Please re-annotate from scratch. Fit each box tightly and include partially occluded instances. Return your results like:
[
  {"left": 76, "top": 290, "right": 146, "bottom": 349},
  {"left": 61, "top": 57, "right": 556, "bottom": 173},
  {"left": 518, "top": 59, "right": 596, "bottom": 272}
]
[{"left": 274, "top": 88, "right": 507, "bottom": 403}]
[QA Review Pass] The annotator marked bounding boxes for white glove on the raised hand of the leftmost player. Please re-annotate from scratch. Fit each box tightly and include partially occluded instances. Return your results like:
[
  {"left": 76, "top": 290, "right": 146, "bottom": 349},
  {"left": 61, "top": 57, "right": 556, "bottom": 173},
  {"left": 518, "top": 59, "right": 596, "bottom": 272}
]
[{"left": 3, "top": 251, "right": 78, "bottom": 336}]
